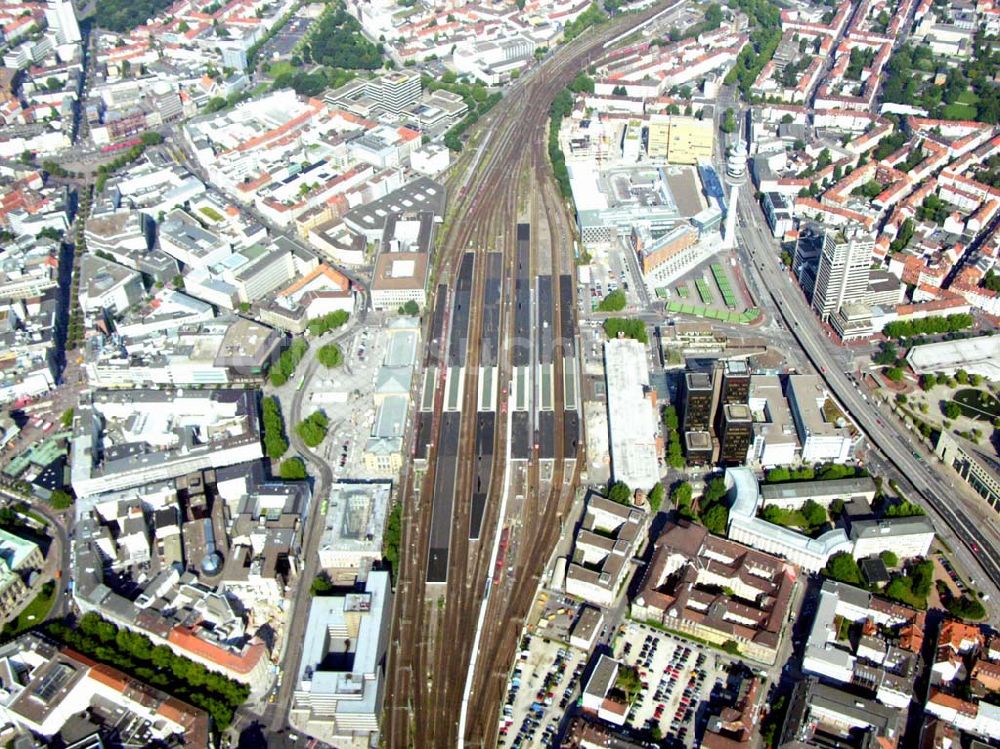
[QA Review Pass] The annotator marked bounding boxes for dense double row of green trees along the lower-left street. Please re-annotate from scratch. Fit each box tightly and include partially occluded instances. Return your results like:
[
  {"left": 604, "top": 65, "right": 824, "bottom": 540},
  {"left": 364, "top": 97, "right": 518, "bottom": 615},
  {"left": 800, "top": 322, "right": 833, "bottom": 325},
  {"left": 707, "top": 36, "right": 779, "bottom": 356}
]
[{"left": 45, "top": 612, "right": 250, "bottom": 732}]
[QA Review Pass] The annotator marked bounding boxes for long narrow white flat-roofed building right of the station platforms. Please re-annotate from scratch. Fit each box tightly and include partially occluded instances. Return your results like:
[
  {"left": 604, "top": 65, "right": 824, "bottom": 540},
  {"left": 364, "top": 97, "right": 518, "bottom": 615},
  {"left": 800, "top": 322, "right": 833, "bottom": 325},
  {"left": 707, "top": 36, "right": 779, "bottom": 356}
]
[{"left": 604, "top": 338, "right": 662, "bottom": 491}]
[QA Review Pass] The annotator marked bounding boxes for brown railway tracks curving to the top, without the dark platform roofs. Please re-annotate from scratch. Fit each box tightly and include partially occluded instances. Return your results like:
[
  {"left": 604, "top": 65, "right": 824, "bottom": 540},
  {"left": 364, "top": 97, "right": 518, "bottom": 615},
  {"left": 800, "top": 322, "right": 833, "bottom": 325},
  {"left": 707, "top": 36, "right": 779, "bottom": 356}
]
[{"left": 383, "top": 8, "right": 672, "bottom": 749}]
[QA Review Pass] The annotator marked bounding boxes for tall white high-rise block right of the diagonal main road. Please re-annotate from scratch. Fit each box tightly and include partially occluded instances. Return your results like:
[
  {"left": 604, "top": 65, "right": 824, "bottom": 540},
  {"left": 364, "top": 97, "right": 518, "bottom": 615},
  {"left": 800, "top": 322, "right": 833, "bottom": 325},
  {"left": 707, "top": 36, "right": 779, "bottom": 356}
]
[{"left": 812, "top": 228, "right": 875, "bottom": 322}]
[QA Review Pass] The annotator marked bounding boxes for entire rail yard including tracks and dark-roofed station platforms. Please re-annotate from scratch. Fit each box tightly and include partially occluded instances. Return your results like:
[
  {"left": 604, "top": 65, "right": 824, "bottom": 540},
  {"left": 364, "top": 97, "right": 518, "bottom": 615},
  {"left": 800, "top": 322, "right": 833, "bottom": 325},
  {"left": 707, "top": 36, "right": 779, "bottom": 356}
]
[{"left": 384, "top": 8, "right": 672, "bottom": 747}]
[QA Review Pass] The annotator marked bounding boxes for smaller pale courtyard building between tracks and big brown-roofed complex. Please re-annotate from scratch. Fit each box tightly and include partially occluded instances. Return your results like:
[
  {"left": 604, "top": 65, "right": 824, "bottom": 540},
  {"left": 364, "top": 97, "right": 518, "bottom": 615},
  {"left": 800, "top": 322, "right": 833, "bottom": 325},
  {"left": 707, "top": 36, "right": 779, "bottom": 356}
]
[{"left": 566, "top": 492, "right": 647, "bottom": 606}]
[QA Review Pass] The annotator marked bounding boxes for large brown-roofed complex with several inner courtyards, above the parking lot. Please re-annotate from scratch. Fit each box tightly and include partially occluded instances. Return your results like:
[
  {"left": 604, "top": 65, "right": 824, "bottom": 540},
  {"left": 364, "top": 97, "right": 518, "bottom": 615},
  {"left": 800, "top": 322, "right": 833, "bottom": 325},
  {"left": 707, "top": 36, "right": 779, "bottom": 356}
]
[{"left": 631, "top": 520, "right": 795, "bottom": 664}]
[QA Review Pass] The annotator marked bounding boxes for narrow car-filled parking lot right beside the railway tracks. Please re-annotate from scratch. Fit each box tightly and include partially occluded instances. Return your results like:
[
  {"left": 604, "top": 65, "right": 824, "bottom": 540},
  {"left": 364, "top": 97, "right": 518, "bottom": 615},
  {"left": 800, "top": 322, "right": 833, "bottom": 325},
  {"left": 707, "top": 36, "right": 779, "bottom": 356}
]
[{"left": 498, "top": 635, "right": 587, "bottom": 749}]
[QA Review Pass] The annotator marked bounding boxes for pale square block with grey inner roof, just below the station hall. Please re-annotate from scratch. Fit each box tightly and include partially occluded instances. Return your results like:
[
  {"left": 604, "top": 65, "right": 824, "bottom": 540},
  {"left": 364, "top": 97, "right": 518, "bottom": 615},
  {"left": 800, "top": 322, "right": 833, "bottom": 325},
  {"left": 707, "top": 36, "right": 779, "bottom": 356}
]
[{"left": 319, "top": 481, "right": 392, "bottom": 582}]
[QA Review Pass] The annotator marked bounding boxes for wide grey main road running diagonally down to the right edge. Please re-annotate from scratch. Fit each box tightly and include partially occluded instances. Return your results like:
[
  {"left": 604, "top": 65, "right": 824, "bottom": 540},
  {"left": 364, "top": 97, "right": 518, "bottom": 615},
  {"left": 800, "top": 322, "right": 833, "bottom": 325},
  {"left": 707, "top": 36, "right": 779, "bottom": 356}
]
[{"left": 738, "top": 177, "right": 1000, "bottom": 609}]
